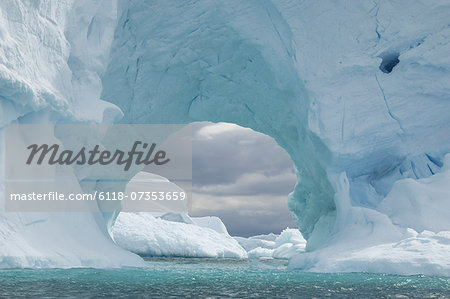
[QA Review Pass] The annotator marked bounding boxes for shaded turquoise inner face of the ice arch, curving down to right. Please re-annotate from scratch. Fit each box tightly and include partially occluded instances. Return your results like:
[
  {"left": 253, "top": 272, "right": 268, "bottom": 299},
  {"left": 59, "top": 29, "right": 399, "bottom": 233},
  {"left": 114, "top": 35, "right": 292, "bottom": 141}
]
[{"left": 102, "top": 1, "right": 335, "bottom": 248}]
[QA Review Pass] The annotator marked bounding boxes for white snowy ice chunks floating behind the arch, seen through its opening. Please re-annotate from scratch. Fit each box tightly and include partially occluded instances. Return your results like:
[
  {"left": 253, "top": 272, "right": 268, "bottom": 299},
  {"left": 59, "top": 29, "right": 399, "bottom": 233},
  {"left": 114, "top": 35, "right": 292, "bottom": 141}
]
[{"left": 111, "top": 213, "right": 306, "bottom": 259}]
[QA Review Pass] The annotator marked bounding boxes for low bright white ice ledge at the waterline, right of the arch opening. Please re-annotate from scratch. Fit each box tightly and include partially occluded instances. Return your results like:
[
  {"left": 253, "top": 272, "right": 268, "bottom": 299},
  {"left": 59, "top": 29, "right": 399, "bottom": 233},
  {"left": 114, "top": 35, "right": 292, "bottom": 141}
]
[{"left": 289, "top": 231, "right": 450, "bottom": 276}]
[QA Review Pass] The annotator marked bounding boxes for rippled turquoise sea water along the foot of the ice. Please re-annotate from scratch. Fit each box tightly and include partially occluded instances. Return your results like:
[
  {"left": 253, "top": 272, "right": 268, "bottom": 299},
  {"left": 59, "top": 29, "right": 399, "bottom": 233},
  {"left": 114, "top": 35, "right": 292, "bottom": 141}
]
[{"left": 0, "top": 258, "right": 450, "bottom": 298}]
